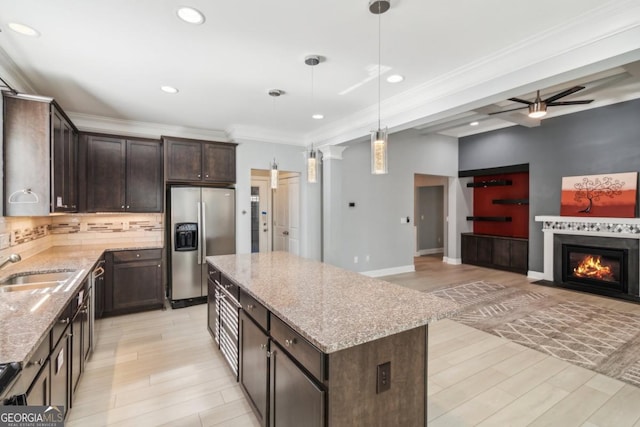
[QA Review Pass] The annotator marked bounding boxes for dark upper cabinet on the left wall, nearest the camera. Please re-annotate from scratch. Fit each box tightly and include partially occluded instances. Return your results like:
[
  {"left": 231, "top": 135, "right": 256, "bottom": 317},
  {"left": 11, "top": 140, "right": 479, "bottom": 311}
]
[{"left": 3, "top": 94, "right": 78, "bottom": 216}]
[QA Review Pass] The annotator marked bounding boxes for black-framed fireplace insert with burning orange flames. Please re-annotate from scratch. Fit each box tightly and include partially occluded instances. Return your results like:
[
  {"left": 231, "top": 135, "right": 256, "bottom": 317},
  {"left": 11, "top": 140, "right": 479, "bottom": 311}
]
[{"left": 561, "top": 244, "right": 629, "bottom": 293}]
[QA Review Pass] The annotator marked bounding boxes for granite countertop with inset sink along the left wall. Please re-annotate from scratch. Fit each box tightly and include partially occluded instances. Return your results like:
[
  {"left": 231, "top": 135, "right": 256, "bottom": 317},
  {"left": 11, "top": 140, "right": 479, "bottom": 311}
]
[{"left": 0, "top": 243, "right": 161, "bottom": 366}]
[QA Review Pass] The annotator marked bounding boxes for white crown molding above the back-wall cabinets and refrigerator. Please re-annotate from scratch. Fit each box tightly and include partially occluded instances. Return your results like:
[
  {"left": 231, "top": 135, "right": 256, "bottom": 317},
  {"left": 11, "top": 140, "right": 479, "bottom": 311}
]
[{"left": 67, "top": 112, "right": 229, "bottom": 142}]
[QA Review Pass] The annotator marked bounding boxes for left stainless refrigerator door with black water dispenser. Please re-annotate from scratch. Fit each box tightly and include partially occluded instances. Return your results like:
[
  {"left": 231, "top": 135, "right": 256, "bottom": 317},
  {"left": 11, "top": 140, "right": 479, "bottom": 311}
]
[{"left": 171, "top": 187, "right": 206, "bottom": 300}]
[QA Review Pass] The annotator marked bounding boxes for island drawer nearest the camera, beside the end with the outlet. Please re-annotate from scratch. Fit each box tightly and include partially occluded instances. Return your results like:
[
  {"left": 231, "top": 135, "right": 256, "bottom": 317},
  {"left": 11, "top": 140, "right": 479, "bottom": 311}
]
[{"left": 270, "top": 313, "right": 324, "bottom": 381}]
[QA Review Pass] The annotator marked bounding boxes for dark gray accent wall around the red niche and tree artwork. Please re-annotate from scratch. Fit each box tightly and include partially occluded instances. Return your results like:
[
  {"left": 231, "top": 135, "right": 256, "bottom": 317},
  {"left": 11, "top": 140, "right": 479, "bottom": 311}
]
[{"left": 459, "top": 100, "right": 640, "bottom": 272}]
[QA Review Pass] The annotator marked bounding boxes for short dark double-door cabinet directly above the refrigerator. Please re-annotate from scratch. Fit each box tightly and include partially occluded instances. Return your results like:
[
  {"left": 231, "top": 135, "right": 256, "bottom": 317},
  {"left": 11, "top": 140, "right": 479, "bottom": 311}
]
[{"left": 163, "top": 136, "right": 236, "bottom": 184}]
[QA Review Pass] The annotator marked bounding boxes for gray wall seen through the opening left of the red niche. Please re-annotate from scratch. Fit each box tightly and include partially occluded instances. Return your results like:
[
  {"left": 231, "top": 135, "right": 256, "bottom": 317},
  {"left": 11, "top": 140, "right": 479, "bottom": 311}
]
[{"left": 415, "top": 185, "right": 444, "bottom": 250}]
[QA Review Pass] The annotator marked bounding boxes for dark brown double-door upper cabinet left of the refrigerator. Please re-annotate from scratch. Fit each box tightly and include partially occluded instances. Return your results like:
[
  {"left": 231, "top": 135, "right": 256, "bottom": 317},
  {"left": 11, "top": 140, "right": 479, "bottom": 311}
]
[{"left": 80, "top": 134, "right": 163, "bottom": 212}]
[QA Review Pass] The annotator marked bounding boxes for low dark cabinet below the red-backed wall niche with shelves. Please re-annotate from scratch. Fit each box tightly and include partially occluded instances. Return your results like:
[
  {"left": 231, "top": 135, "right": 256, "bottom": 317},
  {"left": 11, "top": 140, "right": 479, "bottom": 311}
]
[{"left": 461, "top": 233, "right": 529, "bottom": 274}]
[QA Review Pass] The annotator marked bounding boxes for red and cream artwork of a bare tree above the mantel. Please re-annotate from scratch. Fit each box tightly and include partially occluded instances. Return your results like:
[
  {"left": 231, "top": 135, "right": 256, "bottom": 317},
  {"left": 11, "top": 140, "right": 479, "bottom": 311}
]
[{"left": 560, "top": 172, "right": 638, "bottom": 218}]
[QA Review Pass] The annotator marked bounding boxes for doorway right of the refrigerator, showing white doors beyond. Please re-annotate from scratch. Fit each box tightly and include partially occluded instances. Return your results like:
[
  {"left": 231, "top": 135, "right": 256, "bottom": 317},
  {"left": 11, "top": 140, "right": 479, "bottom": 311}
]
[{"left": 251, "top": 169, "right": 300, "bottom": 255}]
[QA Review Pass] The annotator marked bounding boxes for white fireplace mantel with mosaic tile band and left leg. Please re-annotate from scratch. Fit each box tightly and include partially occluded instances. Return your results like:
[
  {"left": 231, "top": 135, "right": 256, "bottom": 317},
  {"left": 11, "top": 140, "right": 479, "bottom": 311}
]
[{"left": 535, "top": 215, "right": 640, "bottom": 281}]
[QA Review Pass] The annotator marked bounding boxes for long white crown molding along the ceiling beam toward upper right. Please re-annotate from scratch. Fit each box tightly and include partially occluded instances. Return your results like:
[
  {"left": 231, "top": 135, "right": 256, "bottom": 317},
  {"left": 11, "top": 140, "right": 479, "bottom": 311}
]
[{"left": 304, "top": 0, "right": 640, "bottom": 145}]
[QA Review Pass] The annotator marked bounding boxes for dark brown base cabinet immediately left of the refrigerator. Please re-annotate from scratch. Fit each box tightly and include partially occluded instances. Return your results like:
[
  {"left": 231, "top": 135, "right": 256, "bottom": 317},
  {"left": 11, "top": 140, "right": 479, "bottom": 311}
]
[{"left": 103, "top": 249, "right": 163, "bottom": 315}]
